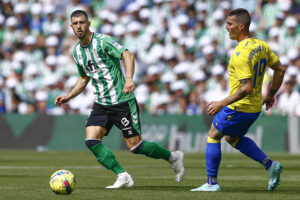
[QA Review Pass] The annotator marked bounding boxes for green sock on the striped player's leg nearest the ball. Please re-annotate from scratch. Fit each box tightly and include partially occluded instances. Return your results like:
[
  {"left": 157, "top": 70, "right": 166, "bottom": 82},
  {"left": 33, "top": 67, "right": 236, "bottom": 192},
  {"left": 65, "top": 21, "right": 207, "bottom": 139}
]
[{"left": 89, "top": 143, "right": 125, "bottom": 174}]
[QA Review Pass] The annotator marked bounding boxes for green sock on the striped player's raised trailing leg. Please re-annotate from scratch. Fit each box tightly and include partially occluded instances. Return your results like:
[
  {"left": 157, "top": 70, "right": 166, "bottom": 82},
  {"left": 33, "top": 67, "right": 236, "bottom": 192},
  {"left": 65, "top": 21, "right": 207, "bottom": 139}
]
[{"left": 138, "top": 141, "right": 171, "bottom": 161}]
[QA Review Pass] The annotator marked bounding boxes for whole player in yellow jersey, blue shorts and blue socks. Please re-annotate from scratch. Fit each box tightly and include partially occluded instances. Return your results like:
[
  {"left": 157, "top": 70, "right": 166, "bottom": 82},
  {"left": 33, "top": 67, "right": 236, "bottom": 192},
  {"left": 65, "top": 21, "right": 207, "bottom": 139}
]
[{"left": 191, "top": 8, "right": 285, "bottom": 191}]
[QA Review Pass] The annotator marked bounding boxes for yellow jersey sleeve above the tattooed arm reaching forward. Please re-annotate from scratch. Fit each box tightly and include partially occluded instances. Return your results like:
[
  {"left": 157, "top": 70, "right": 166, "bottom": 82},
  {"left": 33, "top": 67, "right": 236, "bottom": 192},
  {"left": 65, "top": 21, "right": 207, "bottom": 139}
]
[{"left": 235, "top": 49, "right": 252, "bottom": 80}]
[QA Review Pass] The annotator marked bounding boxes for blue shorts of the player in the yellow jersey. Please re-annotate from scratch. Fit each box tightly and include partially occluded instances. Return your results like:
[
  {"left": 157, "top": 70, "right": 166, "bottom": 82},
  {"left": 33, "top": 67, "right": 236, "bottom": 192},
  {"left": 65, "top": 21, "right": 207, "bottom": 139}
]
[{"left": 213, "top": 106, "right": 260, "bottom": 137}]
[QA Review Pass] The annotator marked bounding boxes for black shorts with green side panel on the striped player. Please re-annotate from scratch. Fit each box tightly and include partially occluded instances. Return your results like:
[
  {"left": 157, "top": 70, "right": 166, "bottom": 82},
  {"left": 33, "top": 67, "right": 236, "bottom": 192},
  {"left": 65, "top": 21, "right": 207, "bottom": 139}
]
[{"left": 86, "top": 99, "right": 141, "bottom": 138}]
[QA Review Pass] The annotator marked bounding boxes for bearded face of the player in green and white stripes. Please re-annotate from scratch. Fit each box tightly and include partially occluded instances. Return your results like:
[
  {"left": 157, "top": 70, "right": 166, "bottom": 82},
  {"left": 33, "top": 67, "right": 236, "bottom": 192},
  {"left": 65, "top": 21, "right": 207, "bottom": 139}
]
[{"left": 71, "top": 15, "right": 91, "bottom": 38}]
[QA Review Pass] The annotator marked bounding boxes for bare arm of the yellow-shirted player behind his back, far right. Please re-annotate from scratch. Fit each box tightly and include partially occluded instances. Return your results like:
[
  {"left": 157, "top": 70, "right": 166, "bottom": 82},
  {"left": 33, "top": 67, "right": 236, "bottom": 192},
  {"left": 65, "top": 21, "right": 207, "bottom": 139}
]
[{"left": 263, "top": 61, "right": 286, "bottom": 110}]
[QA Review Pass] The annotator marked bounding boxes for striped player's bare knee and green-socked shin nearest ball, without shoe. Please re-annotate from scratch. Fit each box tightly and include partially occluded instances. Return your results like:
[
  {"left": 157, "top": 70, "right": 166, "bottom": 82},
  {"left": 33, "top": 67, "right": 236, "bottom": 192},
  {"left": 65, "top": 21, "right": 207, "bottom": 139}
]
[{"left": 85, "top": 126, "right": 125, "bottom": 174}]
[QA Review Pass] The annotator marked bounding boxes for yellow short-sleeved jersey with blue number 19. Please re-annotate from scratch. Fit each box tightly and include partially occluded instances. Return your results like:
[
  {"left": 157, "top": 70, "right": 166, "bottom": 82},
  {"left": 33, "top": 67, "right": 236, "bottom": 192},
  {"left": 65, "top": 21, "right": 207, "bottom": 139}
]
[{"left": 228, "top": 38, "right": 278, "bottom": 113}]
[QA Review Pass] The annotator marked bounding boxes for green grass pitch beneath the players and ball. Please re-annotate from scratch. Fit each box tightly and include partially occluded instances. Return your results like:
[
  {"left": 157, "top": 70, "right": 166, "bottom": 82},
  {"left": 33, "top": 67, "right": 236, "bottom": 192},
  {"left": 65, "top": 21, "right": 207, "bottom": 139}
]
[{"left": 0, "top": 150, "right": 300, "bottom": 200}]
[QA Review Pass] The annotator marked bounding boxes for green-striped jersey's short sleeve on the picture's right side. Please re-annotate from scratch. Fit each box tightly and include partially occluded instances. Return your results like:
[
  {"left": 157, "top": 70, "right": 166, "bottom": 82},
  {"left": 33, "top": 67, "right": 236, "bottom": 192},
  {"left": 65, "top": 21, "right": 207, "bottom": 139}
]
[{"left": 103, "top": 36, "right": 126, "bottom": 59}]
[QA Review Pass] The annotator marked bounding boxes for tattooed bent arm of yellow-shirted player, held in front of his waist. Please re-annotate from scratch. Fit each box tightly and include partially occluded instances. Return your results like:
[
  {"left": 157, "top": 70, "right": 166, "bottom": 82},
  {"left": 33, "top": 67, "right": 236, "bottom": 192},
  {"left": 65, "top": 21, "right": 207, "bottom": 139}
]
[{"left": 206, "top": 78, "right": 253, "bottom": 115}]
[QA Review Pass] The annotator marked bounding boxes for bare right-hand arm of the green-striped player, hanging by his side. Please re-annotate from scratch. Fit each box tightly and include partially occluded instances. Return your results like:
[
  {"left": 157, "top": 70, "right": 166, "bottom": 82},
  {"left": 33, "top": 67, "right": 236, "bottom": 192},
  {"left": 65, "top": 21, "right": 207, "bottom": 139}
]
[{"left": 122, "top": 50, "right": 135, "bottom": 94}]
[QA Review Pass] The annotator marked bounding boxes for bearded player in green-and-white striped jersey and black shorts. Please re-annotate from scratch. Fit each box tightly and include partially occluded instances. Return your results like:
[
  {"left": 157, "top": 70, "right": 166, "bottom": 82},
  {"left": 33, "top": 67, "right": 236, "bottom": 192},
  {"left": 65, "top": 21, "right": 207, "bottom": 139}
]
[{"left": 55, "top": 10, "right": 184, "bottom": 189}]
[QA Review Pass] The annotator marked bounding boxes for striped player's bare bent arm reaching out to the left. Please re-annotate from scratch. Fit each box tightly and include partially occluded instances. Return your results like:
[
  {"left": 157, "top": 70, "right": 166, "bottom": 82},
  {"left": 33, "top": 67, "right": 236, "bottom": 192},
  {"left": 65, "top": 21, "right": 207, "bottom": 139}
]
[{"left": 54, "top": 76, "right": 90, "bottom": 106}]
